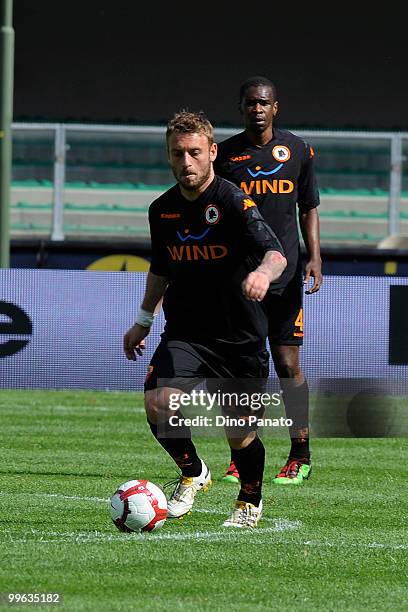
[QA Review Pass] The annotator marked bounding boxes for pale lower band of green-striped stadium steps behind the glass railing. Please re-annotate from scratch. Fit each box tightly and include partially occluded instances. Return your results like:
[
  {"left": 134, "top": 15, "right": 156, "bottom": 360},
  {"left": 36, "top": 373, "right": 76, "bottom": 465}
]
[{"left": 10, "top": 184, "right": 408, "bottom": 244}]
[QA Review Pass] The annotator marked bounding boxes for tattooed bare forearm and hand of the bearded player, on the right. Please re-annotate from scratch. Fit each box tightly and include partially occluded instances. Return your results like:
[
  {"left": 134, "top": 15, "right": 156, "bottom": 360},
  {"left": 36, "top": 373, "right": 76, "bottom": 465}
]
[{"left": 242, "top": 251, "right": 287, "bottom": 302}]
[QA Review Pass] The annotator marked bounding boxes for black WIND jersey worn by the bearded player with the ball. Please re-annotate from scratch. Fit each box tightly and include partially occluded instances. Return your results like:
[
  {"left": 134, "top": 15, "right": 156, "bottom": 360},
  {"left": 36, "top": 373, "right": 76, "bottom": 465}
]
[{"left": 149, "top": 172, "right": 283, "bottom": 354}]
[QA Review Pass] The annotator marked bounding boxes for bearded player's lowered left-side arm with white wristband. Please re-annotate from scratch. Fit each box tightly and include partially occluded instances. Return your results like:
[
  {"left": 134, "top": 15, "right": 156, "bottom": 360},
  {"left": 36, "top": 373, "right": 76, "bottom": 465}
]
[{"left": 123, "top": 272, "right": 168, "bottom": 361}]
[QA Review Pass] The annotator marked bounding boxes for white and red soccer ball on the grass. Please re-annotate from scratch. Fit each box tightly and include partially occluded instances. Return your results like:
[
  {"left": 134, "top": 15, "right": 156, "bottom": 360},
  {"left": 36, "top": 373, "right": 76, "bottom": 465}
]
[{"left": 110, "top": 480, "right": 167, "bottom": 533}]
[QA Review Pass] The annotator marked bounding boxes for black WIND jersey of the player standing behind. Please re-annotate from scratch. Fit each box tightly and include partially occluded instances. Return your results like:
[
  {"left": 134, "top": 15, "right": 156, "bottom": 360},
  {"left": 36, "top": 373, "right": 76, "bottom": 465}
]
[{"left": 214, "top": 128, "right": 319, "bottom": 292}]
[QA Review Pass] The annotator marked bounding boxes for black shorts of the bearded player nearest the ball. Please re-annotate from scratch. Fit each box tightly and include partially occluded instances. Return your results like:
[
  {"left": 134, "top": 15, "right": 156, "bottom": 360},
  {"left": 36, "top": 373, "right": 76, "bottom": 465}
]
[{"left": 144, "top": 339, "right": 269, "bottom": 393}]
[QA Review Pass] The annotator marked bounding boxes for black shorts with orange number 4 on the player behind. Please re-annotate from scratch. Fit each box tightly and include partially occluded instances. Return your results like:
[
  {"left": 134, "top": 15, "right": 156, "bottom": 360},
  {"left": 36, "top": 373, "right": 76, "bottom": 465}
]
[{"left": 264, "top": 274, "right": 303, "bottom": 346}]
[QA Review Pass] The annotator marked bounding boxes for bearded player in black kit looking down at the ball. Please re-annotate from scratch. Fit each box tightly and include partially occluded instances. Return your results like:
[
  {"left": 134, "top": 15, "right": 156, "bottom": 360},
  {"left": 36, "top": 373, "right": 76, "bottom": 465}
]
[{"left": 124, "top": 111, "right": 286, "bottom": 528}]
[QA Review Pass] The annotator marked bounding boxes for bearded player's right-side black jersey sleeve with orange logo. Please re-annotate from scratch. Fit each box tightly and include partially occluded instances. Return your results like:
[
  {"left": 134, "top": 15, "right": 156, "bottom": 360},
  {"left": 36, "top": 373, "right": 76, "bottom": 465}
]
[{"left": 231, "top": 190, "right": 285, "bottom": 256}]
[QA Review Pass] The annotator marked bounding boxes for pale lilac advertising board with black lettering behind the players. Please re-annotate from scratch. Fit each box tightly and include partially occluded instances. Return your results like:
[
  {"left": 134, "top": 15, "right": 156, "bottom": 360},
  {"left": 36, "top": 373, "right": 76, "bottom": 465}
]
[{"left": 0, "top": 269, "right": 408, "bottom": 391}]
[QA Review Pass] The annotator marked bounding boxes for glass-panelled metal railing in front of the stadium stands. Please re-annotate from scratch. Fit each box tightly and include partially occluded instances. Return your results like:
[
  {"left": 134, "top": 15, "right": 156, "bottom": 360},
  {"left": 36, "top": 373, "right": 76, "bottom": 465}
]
[{"left": 11, "top": 123, "right": 408, "bottom": 246}]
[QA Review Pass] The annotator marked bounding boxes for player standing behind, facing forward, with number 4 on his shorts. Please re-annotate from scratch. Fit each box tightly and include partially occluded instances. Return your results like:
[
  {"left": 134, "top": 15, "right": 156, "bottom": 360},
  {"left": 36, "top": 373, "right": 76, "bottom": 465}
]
[{"left": 214, "top": 76, "right": 322, "bottom": 485}]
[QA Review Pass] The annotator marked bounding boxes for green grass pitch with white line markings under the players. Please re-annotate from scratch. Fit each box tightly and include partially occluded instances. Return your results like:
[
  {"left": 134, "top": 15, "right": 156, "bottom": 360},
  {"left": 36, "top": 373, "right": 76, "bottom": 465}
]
[{"left": 0, "top": 390, "right": 408, "bottom": 612}]
